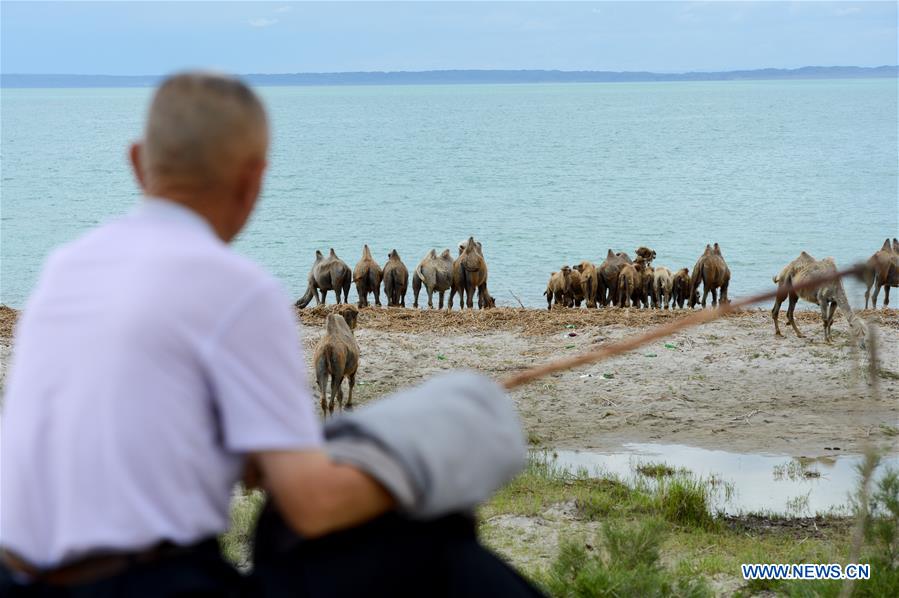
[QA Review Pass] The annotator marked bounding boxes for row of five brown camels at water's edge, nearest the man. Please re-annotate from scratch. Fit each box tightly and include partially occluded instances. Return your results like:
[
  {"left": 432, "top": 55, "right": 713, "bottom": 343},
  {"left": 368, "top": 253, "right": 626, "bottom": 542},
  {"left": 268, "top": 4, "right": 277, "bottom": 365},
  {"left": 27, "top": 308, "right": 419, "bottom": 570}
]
[{"left": 296, "top": 237, "right": 496, "bottom": 309}]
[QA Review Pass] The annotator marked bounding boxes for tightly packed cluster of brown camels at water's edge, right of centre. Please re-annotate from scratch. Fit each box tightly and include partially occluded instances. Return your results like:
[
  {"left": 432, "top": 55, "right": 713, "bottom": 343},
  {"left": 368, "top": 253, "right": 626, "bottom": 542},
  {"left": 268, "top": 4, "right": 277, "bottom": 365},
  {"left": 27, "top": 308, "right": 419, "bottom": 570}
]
[{"left": 543, "top": 243, "right": 730, "bottom": 310}]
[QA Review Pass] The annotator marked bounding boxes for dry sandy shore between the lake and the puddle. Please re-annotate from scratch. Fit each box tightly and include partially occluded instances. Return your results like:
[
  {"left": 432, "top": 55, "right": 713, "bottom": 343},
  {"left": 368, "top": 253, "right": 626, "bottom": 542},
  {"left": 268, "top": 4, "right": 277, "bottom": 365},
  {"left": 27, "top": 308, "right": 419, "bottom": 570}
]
[{"left": 0, "top": 307, "right": 899, "bottom": 456}]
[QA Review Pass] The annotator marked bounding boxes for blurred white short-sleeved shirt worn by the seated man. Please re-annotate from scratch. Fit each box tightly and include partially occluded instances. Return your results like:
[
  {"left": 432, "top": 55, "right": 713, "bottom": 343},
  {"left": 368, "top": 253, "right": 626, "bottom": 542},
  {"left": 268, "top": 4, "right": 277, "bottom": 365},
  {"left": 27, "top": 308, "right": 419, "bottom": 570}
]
[{"left": 0, "top": 199, "right": 321, "bottom": 567}]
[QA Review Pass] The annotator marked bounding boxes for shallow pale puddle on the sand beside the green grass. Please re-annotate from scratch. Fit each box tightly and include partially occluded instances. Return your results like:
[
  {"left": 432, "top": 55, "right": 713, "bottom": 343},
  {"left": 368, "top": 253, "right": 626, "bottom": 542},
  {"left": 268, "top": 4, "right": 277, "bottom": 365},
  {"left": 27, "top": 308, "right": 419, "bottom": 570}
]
[{"left": 546, "top": 443, "right": 899, "bottom": 517}]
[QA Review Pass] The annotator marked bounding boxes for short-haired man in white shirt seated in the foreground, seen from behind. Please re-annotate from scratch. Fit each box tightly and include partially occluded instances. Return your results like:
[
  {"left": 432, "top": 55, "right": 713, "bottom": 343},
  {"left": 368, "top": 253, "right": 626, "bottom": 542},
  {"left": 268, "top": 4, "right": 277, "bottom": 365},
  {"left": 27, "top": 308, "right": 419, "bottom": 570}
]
[{"left": 0, "top": 73, "right": 533, "bottom": 596}]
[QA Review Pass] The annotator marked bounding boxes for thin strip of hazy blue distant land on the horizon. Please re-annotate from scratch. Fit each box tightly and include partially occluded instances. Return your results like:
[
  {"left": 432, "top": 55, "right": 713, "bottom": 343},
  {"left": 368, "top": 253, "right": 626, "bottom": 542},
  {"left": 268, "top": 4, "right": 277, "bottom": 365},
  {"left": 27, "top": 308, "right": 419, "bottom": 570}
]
[{"left": 0, "top": 65, "right": 899, "bottom": 89}]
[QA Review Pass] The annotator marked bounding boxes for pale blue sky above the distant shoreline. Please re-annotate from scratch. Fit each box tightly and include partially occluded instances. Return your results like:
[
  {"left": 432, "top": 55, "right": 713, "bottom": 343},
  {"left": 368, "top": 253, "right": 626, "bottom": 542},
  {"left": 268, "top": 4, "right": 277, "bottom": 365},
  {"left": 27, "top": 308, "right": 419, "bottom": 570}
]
[{"left": 0, "top": 1, "right": 899, "bottom": 75}]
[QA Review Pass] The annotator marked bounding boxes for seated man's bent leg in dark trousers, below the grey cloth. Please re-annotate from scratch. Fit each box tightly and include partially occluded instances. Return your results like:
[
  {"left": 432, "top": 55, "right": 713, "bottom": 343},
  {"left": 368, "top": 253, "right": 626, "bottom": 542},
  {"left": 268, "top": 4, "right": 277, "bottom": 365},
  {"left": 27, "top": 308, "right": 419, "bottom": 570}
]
[{"left": 249, "top": 507, "right": 541, "bottom": 598}]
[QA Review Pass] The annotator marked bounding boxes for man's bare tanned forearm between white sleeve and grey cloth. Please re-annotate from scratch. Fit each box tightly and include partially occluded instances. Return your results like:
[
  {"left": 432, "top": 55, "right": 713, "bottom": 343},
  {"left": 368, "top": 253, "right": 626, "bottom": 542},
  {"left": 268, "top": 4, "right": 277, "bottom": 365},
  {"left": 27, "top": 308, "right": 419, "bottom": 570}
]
[{"left": 251, "top": 450, "right": 396, "bottom": 538}]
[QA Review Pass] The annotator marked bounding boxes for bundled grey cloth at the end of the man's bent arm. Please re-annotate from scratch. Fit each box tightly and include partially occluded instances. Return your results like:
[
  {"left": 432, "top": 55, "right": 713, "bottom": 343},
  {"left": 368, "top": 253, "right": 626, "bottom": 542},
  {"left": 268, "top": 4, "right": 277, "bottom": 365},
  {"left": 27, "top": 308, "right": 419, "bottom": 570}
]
[{"left": 325, "top": 372, "right": 527, "bottom": 518}]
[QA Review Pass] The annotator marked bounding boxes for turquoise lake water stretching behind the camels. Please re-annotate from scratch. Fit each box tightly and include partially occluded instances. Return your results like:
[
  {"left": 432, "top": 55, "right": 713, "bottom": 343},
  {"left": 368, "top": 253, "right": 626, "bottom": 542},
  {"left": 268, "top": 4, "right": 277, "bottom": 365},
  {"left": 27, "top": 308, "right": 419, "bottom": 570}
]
[{"left": 0, "top": 79, "right": 899, "bottom": 307}]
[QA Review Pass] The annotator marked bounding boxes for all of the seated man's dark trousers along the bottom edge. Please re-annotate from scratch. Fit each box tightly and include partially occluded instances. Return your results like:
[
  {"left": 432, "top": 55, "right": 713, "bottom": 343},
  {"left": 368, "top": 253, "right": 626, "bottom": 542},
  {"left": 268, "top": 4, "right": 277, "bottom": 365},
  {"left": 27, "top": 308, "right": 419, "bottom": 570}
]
[{"left": 0, "top": 507, "right": 541, "bottom": 598}]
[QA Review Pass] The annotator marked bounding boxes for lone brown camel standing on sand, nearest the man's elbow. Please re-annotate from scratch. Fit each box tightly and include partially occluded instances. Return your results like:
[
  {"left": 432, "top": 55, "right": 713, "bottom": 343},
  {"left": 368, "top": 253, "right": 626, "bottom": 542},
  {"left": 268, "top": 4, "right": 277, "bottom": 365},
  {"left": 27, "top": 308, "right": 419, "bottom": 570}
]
[{"left": 312, "top": 305, "right": 359, "bottom": 417}]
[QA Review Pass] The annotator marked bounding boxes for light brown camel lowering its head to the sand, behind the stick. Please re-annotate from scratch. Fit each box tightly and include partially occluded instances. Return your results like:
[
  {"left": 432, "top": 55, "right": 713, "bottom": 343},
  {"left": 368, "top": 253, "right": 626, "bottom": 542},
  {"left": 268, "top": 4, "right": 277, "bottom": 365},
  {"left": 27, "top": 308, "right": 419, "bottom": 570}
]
[{"left": 771, "top": 251, "right": 867, "bottom": 347}]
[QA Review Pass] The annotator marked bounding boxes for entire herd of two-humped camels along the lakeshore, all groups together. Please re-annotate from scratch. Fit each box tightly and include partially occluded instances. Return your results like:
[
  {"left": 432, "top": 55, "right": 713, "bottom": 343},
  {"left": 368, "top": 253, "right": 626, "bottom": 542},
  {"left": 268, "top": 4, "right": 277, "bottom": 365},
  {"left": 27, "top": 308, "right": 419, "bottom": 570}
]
[{"left": 306, "top": 237, "right": 899, "bottom": 416}]
